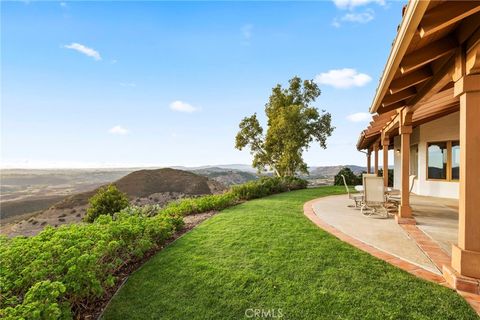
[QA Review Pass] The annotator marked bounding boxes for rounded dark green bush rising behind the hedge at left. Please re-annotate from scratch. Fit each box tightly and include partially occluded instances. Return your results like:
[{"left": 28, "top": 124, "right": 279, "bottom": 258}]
[{"left": 85, "top": 184, "right": 129, "bottom": 222}]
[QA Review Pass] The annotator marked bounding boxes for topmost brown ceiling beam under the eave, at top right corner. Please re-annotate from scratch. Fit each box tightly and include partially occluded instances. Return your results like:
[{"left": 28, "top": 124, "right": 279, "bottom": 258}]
[{"left": 418, "top": 1, "right": 480, "bottom": 38}]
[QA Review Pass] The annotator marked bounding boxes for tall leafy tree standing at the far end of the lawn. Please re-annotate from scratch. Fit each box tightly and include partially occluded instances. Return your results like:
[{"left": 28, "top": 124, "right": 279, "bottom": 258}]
[{"left": 235, "top": 77, "right": 334, "bottom": 177}]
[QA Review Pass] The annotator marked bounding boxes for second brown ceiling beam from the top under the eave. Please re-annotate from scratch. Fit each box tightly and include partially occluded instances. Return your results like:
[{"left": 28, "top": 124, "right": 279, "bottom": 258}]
[{"left": 400, "top": 37, "right": 457, "bottom": 73}]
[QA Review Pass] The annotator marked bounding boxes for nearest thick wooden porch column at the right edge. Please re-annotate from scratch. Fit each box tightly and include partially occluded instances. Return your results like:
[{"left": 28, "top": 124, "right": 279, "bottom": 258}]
[{"left": 452, "top": 67, "right": 480, "bottom": 279}]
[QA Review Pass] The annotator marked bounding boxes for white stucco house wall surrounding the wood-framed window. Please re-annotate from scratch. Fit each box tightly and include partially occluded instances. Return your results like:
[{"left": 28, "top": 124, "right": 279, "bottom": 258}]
[{"left": 394, "top": 112, "right": 460, "bottom": 199}]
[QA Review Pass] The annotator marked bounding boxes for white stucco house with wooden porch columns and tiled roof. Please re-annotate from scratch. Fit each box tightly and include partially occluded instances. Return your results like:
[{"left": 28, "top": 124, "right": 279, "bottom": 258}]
[{"left": 357, "top": 0, "right": 480, "bottom": 294}]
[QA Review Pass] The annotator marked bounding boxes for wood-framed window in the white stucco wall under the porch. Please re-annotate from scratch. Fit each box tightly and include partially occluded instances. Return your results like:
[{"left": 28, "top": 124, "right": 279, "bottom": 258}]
[{"left": 427, "top": 141, "right": 460, "bottom": 181}]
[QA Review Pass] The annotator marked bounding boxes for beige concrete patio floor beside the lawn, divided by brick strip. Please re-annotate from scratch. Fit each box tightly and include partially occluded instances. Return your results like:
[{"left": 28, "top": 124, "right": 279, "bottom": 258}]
[{"left": 313, "top": 195, "right": 458, "bottom": 274}]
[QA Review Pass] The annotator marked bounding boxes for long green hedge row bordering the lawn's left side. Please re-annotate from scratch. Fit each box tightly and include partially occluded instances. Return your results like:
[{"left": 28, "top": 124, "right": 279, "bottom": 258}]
[{"left": 0, "top": 178, "right": 306, "bottom": 319}]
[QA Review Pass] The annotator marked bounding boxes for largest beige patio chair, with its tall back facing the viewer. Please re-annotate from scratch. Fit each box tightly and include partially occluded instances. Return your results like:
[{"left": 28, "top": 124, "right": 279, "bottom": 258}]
[{"left": 361, "top": 176, "right": 388, "bottom": 218}]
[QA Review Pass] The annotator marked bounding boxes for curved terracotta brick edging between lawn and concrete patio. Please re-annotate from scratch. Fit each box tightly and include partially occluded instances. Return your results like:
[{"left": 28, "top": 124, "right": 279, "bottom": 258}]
[{"left": 303, "top": 198, "right": 480, "bottom": 315}]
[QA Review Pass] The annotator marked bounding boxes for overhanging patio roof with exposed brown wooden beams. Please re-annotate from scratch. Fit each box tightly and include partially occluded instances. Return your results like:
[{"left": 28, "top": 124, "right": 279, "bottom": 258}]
[{"left": 357, "top": 1, "right": 480, "bottom": 150}]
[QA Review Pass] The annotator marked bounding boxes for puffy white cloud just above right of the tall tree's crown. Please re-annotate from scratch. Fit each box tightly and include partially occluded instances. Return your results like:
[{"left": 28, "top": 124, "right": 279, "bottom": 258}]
[{"left": 315, "top": 68, "right": 372, "bottom": 89}]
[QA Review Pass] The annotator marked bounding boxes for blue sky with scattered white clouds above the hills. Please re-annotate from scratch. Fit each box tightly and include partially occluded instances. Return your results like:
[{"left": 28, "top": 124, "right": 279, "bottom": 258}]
[{"left": 0, "top": 0, "right": 405, "bottom": 168}]
